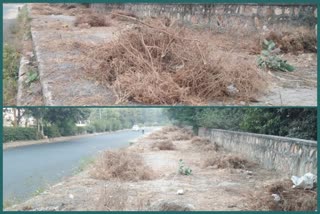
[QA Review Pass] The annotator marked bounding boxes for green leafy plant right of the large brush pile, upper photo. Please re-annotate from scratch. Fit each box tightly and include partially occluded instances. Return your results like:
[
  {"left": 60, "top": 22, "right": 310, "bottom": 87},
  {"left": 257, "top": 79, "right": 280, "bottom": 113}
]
[{"left": 258, "top": 40, "right": 295, "bottom": 72}]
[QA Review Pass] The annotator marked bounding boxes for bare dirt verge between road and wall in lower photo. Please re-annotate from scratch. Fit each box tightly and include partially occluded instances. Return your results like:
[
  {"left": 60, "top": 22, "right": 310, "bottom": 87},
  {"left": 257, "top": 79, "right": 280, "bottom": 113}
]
[{"left": 7, "top": 127, "right": 288, "bottom": 211}]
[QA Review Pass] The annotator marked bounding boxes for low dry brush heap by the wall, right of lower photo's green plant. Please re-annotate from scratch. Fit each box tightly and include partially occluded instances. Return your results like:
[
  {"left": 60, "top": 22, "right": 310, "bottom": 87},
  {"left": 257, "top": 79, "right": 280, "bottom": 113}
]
[{"left": 203, "top": 153, "right": 252, "bottom": 169}]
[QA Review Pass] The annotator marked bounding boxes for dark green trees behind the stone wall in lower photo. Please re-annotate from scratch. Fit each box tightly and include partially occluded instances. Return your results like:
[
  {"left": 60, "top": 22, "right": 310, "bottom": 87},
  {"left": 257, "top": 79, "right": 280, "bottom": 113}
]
[{"left": 166, "top": 107, "right": 317, "bottom": 140}]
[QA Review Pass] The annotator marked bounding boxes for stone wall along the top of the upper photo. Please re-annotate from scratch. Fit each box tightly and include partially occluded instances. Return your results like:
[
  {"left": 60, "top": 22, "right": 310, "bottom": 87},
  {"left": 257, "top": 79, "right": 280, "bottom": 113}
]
[{"left": 91, "top": 3, "right": 317, "bottom": 31}]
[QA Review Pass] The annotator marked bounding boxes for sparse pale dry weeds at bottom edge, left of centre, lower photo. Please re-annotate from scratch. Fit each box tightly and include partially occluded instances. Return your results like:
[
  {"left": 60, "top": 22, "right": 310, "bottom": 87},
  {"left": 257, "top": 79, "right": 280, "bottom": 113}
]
[{"left": 97, "top": 183, "right": 128, "bottom": 211}]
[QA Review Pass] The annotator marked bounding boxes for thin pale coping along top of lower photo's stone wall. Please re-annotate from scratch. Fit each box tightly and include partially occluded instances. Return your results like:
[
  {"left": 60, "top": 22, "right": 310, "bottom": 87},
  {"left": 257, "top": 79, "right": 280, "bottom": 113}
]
[{"left": 201, "top": 127, "right": 317, "bottom": 147}]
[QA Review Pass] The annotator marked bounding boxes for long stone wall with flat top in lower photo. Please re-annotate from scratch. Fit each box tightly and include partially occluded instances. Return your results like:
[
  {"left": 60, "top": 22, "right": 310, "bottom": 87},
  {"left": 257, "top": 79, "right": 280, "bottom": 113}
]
[{"left": 199, "top": 128, "right": 317, "bottom": 176}]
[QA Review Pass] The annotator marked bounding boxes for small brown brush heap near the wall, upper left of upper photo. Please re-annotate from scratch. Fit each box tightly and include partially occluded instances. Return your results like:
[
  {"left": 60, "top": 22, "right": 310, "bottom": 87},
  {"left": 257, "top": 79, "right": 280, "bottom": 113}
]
[{"left": 75, "top": 13, "right": 111, "bottom": 27}]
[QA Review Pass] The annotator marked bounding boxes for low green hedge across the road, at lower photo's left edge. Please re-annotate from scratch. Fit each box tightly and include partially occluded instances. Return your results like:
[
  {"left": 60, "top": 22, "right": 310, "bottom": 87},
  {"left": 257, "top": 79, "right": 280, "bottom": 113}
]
[{"left": 3, "top": 127, "right": 39, "bottom": 142}]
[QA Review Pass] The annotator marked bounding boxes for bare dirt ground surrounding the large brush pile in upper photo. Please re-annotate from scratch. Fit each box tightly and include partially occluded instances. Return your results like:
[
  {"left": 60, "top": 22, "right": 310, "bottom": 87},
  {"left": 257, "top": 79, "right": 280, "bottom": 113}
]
[{"left": 21, "top": 5, "right": 317, "bottom": 106}]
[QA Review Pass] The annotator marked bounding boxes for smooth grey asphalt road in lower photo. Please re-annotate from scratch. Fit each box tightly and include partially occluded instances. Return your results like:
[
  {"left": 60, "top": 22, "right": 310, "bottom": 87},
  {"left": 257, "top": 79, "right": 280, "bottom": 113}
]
[{"left": 3, "top": 128, "right": 154, "bottom": 201}]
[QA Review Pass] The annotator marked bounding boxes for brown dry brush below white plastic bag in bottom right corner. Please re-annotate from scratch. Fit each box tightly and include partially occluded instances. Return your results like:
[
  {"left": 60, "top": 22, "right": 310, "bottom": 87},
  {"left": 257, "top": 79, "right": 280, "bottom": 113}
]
[{"left": 252, "top": 179, "right": 317, "bottom": 211}]
